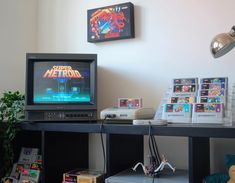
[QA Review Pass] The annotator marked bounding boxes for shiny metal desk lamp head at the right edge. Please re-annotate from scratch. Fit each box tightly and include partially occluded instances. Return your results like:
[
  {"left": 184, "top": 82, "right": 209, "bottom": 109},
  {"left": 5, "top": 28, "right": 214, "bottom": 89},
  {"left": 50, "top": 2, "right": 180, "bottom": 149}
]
[{"left": 211, "top": 26, "right": 235, "bottom": 58}]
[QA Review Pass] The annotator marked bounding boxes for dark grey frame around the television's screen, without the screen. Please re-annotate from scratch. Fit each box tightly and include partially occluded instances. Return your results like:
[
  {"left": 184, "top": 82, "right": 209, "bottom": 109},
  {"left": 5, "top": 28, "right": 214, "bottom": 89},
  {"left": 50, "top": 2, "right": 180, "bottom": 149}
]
[{"left": 25, "top": 53, "right": 97, "bottom": 111}]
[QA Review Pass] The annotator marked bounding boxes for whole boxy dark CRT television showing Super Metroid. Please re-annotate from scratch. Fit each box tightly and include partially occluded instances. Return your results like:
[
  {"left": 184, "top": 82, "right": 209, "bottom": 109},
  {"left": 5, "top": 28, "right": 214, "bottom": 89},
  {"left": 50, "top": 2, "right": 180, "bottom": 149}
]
[{"left": 25, "top": 53, "right": 97, "bottom": 121}]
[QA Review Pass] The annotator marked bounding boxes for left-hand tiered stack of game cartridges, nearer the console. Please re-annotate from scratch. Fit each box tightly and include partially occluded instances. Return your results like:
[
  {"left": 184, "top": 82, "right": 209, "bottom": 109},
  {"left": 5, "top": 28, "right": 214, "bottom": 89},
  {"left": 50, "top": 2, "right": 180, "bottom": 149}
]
[{"left": 163, "top": 78, "right": 198, "bottom": 123}]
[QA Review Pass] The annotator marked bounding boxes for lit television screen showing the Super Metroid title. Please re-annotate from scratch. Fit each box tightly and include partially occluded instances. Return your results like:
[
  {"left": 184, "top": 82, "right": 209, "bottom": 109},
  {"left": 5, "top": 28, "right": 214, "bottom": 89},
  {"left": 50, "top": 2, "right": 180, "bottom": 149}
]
[{"left": 33, "top": 61, "right": 91, "bottom": 104}]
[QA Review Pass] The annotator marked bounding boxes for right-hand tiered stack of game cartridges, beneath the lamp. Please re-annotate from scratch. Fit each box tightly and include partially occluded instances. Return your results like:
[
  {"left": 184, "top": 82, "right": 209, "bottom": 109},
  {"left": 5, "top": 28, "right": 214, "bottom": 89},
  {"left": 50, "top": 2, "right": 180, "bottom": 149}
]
[{"left": 192, "top": 77, "right": 228, "bottom": 123}]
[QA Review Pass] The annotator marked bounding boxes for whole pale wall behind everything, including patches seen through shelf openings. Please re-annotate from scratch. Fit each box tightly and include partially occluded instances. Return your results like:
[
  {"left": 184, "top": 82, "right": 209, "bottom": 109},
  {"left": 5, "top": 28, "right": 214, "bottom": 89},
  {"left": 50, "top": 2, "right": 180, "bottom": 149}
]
[{"left": 0, "top": 0, "right": 235, "bottom": 174}]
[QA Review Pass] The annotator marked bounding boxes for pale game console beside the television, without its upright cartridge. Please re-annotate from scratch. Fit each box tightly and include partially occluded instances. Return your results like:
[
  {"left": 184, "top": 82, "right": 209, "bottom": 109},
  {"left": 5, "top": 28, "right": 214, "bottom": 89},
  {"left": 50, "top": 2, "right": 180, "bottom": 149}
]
[{"left": 100, "top": 107, "right": 155, "bottom": 120}]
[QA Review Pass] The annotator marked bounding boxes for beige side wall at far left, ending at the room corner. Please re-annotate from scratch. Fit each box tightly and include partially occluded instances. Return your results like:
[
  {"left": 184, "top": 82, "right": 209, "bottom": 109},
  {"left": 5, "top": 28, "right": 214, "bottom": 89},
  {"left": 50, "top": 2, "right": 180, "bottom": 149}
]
[{"left": 0, "top": 0, "right": 37, "bottom": 93}]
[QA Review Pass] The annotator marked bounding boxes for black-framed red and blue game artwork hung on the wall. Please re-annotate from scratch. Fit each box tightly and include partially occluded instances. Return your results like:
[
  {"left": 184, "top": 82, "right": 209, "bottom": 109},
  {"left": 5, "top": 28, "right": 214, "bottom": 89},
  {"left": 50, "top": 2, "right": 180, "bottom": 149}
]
[{"left": 87, "top": 2, "right": 135, "bottom": 43}]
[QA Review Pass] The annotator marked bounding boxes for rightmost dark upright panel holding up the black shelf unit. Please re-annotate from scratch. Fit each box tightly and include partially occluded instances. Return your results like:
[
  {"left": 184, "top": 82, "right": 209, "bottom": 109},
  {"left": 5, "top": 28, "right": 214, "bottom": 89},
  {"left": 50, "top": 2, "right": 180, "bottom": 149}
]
[{"left": 188, "top": 137, "right": 210, "bottom": 183}]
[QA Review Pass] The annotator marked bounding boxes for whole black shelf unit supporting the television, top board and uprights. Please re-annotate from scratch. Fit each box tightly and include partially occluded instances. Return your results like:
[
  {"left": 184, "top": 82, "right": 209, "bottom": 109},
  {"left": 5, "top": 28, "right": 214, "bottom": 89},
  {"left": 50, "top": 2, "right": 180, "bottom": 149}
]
[{"left": 13, "top": 123, "right": 235, "bottom": 183}]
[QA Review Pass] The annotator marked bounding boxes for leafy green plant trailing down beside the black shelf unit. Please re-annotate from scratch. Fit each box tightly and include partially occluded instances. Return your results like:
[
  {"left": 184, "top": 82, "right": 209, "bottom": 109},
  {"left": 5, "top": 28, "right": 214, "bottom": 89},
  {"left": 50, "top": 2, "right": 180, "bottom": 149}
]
[{"left": 0, "top": 91, "right": 24, "bottom": 177}]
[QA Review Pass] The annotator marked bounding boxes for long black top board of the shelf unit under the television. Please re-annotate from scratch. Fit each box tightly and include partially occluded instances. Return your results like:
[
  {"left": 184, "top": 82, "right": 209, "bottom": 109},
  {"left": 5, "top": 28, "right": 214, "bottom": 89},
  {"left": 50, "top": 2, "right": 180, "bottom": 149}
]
[{"left": 20, "top": 122, "right": 235, "bottom": 138}]
